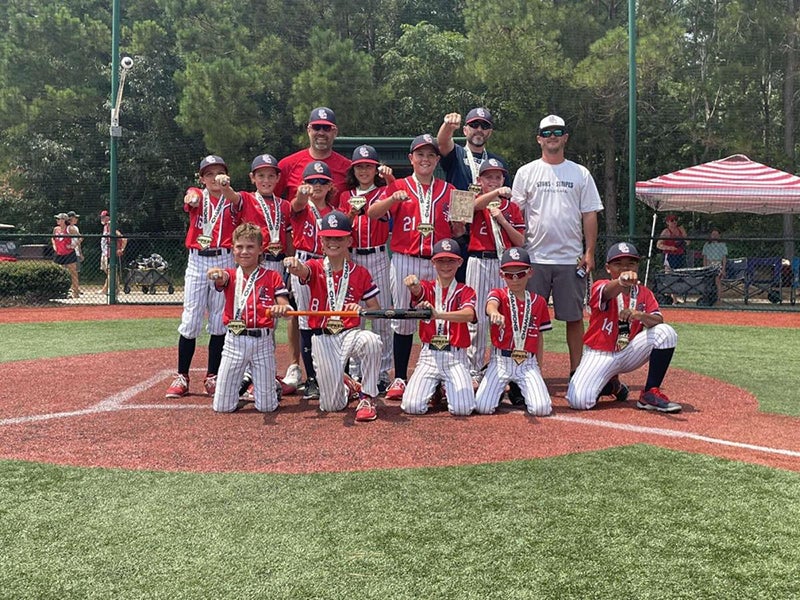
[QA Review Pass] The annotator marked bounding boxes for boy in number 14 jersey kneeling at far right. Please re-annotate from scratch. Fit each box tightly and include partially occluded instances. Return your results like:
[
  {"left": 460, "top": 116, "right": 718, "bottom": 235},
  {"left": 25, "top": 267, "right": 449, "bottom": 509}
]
[{"left": 567, "top": 242, "right": 681, "bottom": 413}]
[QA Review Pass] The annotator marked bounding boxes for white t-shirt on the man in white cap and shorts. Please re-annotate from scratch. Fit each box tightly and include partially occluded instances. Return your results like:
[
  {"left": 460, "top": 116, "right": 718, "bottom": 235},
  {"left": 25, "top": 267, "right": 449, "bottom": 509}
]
[{"left": 511, "top": 158, "right": 603, "bottom": 265}]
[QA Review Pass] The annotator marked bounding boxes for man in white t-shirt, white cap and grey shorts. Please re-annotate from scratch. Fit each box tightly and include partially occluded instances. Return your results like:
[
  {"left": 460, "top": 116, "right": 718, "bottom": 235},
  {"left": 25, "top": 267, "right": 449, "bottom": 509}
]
[{"left": 511, "top": 115, "right": 603, "bottom": 373}]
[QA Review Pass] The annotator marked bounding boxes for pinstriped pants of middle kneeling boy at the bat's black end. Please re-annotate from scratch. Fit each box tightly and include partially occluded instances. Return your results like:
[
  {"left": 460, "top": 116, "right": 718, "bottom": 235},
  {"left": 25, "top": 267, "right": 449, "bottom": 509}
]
[{"left": 400, "top": 344, "right": 475, "bottom": 416}]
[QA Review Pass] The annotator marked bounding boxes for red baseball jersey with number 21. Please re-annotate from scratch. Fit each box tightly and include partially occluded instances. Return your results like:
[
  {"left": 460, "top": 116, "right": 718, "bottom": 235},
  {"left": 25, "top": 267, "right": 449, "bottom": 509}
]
[{"left": 382, "top": 177, "right": 455, "bottom": 256}]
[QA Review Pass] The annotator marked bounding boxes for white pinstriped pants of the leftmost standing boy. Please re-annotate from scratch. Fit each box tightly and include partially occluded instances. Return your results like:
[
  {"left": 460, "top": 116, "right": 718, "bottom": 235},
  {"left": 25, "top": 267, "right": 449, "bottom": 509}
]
[{"left": 178, "top": 251, "right": 233, "bottom": 340}]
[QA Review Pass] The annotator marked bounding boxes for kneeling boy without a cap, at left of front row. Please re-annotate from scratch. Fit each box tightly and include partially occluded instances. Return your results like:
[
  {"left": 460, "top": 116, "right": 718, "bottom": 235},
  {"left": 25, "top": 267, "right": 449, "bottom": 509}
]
[{"left": 207, "top": 223, "right": 289, "bottom": 412}]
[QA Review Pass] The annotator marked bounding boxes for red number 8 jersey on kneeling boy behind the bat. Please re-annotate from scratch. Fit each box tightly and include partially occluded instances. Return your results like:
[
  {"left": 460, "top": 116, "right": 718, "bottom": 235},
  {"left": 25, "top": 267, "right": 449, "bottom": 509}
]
[{"left": 300, "top": 258, "right": 380, "bottom": 329}]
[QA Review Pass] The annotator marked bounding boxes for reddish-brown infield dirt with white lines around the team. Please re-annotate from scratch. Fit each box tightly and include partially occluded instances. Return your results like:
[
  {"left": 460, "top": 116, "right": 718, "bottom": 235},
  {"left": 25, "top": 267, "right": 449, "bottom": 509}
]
[{"left": 0, "top": 306, "right": 800, "bottom": 473}]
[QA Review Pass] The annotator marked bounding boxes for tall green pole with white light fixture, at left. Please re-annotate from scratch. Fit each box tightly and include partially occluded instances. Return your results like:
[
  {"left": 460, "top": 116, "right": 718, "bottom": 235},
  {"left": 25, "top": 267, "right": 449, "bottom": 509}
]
[{"left": 108, "top": 0, "right": 133, "bottom": 304}]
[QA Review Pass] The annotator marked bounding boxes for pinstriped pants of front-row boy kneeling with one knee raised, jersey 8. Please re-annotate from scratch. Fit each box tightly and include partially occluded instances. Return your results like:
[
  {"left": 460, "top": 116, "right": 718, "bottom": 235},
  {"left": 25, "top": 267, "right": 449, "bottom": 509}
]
[{"left": 311, "top": 327, "right": 383, "bottom": 411}]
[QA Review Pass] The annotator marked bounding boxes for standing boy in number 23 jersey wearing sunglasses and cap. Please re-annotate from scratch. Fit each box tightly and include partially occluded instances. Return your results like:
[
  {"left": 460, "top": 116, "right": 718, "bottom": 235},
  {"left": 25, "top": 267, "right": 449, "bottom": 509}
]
[{"left": 290, "top": 160, "right": 336, "bottom": 400}]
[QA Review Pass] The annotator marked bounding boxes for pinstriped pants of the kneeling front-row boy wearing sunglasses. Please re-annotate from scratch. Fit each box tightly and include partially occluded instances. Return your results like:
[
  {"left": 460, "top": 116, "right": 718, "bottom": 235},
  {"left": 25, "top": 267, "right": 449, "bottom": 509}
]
[{"left": 475, "top": 350, "right": 553, "bottom": 417}]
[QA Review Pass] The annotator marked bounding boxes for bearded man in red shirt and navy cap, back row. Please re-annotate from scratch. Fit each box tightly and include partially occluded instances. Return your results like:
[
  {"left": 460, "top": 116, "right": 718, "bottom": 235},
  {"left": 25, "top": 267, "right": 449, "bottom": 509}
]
[{"left": 275, "top": 106, "right": 350, "bottom": 201}]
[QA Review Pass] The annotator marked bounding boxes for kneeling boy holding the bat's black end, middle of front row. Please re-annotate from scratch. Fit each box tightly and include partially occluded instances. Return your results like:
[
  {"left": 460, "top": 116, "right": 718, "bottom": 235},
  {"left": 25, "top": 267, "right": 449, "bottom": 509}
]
[{"left": 400, "top": 239, "right": 476, "bottom": 415}]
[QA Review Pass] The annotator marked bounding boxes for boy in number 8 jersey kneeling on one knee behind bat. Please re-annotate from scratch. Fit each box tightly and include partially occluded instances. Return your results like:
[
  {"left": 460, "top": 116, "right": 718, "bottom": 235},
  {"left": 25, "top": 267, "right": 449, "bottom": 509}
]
[{"left": 286, "top": 211, "right": 382, "bottom": 421}]
